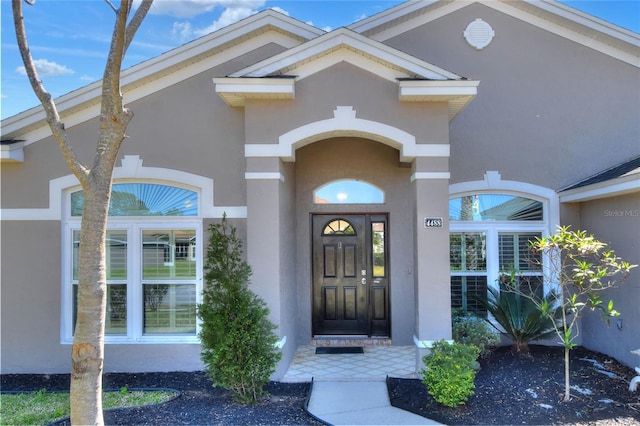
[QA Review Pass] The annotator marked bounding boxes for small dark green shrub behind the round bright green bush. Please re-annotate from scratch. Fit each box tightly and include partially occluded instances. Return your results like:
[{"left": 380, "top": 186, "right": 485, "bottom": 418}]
[{"left": 452, "top": 309, "right": 500, "bottom": 358}]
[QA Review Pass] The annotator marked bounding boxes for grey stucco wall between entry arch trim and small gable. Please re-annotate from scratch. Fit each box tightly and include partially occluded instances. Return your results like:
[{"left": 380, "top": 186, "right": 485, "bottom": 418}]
[{"left": 245, "top": 62, "right": 449, "bottom": 148}]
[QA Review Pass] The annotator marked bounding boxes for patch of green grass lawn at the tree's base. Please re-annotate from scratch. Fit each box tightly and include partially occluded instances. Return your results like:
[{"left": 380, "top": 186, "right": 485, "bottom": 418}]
[{"left": 0, "top": 388, "right": 176, "bottom": 425}]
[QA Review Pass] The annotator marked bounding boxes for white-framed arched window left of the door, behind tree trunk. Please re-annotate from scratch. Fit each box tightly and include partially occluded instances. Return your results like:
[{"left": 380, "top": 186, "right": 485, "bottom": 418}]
[{"left": 62, "top": 183, "right": 202, "bottom": 343}]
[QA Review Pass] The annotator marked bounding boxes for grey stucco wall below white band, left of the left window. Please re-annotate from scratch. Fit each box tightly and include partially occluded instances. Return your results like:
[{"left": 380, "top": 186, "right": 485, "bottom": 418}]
[{"left": 0, "top": 221, "right": 71, "bottom": 373}]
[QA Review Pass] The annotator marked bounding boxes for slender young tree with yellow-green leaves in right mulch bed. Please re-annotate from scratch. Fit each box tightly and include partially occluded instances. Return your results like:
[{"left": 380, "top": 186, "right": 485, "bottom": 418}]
[{"left": 523, "top": 227, "right": 637, "bottom": 401}]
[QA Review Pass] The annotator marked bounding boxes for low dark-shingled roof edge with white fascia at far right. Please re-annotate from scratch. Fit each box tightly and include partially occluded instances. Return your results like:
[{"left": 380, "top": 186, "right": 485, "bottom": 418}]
[{"left": 558, "top": 156, "right": 640, "bottom": 202}]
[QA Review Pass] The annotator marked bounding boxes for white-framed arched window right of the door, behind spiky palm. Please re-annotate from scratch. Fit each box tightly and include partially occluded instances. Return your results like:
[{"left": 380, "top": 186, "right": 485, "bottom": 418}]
[{"left": 449, "top": 193, "right": 548, "bottom": 316}]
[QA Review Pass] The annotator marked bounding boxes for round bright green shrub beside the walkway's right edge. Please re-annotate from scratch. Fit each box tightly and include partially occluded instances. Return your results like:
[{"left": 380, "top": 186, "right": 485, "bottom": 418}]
[{"left": 421, "top": 340, "right": 479, "bottom": 407}]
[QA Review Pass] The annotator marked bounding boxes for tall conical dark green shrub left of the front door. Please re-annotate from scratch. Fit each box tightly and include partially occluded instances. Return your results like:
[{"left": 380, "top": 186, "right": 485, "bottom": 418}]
[{"left": 198, "top": 217, "right": 281, "bottom": 404}]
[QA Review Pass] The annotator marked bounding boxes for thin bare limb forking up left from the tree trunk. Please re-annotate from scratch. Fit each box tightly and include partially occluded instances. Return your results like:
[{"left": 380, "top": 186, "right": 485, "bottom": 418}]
[{"left": 12, "top": 0, "right": 89, "bottom": 186}]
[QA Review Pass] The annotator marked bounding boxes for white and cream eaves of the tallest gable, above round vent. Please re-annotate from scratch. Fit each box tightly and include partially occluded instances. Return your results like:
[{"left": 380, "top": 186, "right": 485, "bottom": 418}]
[{"left": 348, "top": 0, "right": 640, "bottom": 67}]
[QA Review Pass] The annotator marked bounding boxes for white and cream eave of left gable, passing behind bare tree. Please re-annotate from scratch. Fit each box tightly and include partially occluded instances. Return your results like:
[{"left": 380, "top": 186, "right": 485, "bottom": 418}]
[{"left": 1, "top": 10, "right": 325, "bottom": 145}]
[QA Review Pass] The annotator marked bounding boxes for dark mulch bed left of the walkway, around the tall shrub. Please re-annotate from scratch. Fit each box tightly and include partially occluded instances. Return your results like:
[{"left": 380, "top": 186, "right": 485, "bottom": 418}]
[{"left": 1, "top": 372, "right": 322, "bottom": 425}]
